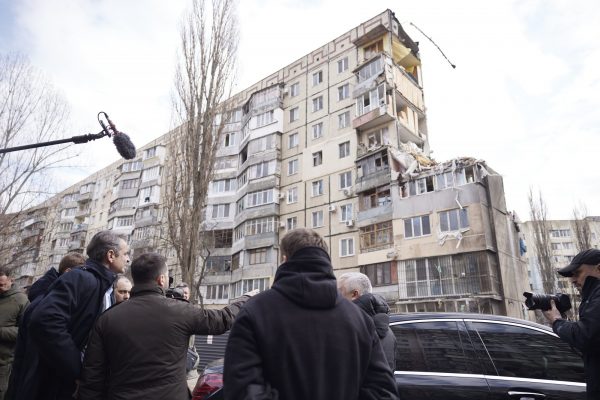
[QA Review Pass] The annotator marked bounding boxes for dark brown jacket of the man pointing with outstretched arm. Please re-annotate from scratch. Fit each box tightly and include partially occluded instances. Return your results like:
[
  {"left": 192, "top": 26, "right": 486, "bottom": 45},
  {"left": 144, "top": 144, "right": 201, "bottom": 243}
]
[{"left": 79, "top": 284, "right": 248, "bottom": 400}]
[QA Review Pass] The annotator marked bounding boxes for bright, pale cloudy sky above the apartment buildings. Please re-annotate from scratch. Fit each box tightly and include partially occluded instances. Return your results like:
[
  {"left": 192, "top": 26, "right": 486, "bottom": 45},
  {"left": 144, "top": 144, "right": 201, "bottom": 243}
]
[{"left": 0, "top": 0, "right": 600, "bottom": 220}]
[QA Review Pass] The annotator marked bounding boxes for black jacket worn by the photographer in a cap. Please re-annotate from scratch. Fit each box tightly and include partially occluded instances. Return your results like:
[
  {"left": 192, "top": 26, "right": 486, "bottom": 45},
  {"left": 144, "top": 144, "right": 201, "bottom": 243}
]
[{"left": 552, "top": 276, "right": 600, "bottom": 400}]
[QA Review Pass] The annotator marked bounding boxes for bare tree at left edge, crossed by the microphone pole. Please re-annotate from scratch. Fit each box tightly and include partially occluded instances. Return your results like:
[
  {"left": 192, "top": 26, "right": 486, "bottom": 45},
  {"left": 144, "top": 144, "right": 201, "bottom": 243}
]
[{"left": 0, "top": 54, "right": 70, "bottom": 272}]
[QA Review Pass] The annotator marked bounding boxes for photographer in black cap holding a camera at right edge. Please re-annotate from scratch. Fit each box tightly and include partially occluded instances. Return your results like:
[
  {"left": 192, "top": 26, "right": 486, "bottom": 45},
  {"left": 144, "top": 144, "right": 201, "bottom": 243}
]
[{"left": 543, "top": 249, "right": 600, "bottom": 399}]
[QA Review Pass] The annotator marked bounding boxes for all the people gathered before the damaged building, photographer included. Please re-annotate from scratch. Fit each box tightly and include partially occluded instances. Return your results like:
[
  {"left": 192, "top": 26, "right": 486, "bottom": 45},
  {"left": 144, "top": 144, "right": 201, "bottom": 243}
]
[{"left": 0, "top": 228, "right": 600, "bottom": 400}]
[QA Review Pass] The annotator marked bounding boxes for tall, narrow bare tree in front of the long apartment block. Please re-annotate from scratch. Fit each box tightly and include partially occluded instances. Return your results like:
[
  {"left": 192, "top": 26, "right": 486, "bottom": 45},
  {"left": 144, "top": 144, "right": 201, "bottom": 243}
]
[{"left": 164, "top": 0, "right": 238, "bottom": 304}]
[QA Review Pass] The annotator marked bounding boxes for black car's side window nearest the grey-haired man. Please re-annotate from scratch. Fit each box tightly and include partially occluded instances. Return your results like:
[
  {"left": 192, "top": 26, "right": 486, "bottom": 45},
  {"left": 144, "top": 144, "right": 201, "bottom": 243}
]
[{"left": 391, "top": 321, "right": 474, "bottom": 373}]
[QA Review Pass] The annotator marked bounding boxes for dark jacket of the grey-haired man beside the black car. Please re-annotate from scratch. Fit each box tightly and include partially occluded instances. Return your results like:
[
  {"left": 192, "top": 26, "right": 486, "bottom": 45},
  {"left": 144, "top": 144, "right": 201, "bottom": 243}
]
[{"left": 353, "top": 293, "right": 396, "bottom": 371}]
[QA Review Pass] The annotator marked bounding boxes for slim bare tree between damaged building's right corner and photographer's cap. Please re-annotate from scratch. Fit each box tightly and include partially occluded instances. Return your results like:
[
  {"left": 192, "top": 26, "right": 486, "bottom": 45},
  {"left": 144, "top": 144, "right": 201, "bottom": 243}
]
[{"left": 528, "top": 188, "right": 556, "bottom": 293}]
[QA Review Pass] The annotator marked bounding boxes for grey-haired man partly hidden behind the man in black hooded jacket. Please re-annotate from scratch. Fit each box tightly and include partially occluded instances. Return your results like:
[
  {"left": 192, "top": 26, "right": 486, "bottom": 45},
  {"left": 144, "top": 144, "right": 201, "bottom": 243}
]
[{"left": 338, "top": 272, "right": 396, "bottom": 371}]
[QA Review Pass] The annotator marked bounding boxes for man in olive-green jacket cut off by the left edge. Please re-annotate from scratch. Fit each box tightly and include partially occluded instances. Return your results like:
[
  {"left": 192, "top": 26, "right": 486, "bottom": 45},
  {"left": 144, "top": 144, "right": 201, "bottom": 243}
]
[{"left": 0, "top": 267, "right": 29, "bottom": 400}]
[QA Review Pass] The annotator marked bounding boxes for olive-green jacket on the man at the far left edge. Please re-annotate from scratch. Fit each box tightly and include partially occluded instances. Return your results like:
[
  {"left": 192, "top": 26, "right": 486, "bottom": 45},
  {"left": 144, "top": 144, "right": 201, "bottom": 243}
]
[{"left": 0, "top": 287, "right": 29, "bottom": 366}]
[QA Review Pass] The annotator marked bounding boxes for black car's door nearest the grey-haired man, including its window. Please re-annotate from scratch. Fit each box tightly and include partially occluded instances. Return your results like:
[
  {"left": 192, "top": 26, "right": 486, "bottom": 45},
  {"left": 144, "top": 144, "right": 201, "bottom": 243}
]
[{"left": 390, "top": 319, "right": 489, "bottom": 400}]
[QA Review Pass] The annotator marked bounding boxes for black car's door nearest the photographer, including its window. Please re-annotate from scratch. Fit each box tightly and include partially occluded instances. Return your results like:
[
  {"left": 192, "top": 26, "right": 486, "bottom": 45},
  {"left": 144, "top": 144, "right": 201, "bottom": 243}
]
[{"left": 466, "top": 320, "right": 585, "bottom": 400}]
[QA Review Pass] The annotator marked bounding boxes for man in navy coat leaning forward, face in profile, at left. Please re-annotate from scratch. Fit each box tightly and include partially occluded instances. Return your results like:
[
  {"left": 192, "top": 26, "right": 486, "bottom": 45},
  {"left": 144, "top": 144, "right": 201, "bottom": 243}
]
[{"left": 9, "top": 231, "right": 129, "bottom": 400}]
